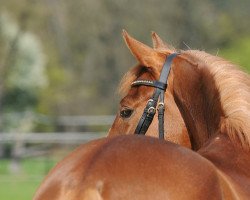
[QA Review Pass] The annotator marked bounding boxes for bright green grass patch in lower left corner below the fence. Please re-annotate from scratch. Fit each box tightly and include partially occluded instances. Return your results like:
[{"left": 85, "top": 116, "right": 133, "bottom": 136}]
[{"left": 0, "top": 158, "right": 56, "bottom": 200}]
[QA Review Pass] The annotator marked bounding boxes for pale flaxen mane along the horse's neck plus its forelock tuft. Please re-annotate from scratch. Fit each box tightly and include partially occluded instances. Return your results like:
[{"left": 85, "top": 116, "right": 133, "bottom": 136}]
[{"left": 119, "top": 50, "right": 250, "bottom": 149}]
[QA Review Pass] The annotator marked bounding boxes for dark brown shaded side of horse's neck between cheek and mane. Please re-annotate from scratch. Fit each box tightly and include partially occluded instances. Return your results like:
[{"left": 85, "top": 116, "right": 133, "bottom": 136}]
[{"left": 173, "top": 61, "right": 223, "bottom": 150}]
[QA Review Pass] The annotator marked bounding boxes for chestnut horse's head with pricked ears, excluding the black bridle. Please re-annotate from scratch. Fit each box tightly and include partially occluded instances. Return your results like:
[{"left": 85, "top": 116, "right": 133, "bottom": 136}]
[{"left": 109, "top": 31, "right": 191, "bottom": 147}]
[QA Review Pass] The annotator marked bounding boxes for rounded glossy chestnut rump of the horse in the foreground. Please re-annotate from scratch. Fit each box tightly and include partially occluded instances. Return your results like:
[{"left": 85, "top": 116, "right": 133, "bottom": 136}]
[{"left": 35, "top": 136, "right": 225, "bottom": 200}]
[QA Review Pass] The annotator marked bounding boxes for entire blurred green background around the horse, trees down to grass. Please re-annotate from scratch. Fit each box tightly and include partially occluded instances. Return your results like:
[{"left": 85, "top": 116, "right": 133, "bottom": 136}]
[{"left": 0, "top": 0, "right": 250, "bottom": 200}]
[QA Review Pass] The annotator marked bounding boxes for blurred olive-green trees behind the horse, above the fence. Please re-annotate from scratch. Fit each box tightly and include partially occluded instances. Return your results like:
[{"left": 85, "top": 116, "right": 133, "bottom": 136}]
[{"left": 0, "top": 0, "right": 250, "bottom": 131}]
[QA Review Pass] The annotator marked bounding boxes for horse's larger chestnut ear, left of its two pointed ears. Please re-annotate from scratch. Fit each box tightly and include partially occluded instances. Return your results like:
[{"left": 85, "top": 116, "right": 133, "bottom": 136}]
[{"left": 123, "top": 30, "right": 162, "bottom": 67}]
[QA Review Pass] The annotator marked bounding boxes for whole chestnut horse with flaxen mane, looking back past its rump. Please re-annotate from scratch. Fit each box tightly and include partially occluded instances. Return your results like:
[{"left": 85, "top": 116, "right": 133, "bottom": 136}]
[{"left": 34, "top": 32, "right": 250, "bottom": 200}]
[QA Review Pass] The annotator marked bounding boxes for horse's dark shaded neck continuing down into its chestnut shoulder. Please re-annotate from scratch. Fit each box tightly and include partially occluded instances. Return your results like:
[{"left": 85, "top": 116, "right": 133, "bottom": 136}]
[{"left": 173, "top": 59, "right": 250, "bottom": 196}]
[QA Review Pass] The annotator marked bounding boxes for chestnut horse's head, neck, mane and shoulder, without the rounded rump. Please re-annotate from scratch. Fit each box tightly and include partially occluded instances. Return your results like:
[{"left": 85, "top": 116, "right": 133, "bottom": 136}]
[{"left": 109, "top": 32, "right": 250, "bottom": 198}]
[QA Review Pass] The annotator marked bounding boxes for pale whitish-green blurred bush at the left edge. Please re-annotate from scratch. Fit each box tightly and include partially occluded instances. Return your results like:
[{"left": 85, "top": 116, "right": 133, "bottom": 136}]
[{"left": 0, "top": 13, "right": 47, "bottom": 131}]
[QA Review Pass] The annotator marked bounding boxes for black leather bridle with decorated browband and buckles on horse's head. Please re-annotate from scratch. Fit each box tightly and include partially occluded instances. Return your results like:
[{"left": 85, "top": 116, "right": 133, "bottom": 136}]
[{"left": 131, "top": 53, "right": 179, "bottom": 139}]
